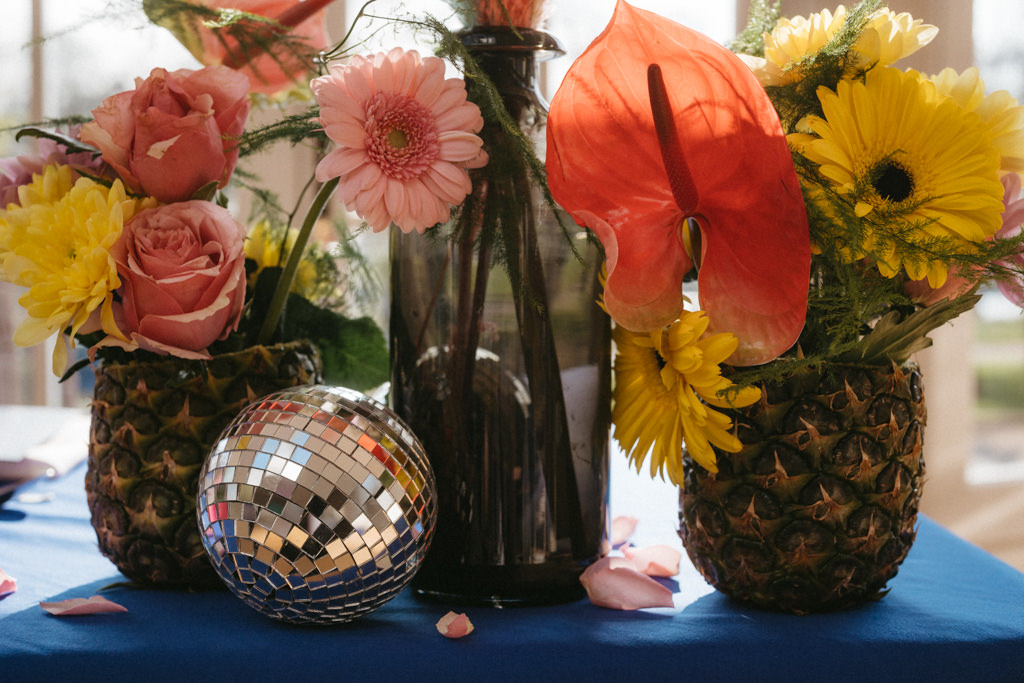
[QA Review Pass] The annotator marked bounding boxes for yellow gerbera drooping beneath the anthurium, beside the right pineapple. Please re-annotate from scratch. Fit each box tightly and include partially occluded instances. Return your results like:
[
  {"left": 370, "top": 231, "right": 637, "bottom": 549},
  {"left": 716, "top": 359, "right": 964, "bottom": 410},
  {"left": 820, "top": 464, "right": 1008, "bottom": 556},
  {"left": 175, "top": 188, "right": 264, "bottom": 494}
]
[{"left": 611, "top": 310, "right": 761, "bottom": 486}]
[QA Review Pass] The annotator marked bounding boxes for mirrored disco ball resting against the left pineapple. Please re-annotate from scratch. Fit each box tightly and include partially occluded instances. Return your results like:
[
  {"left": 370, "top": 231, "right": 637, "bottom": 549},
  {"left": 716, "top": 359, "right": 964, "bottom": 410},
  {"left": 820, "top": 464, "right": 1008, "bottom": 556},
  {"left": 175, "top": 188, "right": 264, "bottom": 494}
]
[{"left": 197, "top": 386, "right": 437, "bottom": 624}]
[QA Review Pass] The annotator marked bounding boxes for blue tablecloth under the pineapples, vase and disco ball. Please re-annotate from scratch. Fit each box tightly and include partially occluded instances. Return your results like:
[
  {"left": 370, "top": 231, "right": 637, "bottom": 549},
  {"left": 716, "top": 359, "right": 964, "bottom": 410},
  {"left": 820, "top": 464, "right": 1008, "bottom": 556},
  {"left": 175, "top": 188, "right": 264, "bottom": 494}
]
[{"left": 0, "top": 456, "right": 1024, "bottom": 683}]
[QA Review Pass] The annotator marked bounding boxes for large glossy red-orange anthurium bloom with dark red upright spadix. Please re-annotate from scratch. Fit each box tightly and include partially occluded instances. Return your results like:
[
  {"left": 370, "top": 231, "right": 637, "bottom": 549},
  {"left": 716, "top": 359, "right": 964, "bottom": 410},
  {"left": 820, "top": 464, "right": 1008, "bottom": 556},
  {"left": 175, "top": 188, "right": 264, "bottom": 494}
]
[{"left": 547, "top": 0, "right": 810, "bottom": 366}]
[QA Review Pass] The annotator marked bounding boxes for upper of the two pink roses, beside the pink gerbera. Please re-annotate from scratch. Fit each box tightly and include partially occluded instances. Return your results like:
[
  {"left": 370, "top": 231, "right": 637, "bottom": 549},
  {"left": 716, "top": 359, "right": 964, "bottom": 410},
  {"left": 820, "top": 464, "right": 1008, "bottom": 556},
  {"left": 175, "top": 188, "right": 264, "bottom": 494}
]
[{"left": 82, "top": 67, "right": 249, "bottom": 202}]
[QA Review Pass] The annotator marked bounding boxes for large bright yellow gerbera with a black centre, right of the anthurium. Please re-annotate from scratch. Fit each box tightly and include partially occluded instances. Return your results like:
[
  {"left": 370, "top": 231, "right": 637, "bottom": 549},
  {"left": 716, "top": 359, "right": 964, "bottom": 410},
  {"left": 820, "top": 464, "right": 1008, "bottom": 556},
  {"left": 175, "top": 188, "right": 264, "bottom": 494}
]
[{"left": 788, "top": 68, "right": 1002, "bottom": 288}]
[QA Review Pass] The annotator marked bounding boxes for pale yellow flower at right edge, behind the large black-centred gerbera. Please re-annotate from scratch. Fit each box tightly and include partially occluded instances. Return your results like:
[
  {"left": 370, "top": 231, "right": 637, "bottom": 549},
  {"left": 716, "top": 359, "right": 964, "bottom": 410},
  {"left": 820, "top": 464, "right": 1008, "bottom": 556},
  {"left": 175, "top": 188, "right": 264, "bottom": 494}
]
[{"left": 931, "top": 67, "right": 1024, "bottom": 173}]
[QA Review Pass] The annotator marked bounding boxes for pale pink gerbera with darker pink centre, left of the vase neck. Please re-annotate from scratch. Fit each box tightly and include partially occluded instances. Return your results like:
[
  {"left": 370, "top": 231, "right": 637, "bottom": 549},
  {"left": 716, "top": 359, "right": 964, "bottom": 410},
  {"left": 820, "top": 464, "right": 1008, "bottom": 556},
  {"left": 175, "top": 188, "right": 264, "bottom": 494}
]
[{"left": 310, "top": 48, "right": 486, "bottom": 232}]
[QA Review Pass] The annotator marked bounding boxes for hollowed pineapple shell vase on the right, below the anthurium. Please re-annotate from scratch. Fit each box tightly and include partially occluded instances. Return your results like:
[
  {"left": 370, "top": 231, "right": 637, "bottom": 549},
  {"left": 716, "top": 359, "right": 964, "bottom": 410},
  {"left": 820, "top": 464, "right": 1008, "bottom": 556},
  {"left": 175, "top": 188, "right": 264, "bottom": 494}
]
[{"left": 679, "top": 364, "right": 926, "bottom": 613}]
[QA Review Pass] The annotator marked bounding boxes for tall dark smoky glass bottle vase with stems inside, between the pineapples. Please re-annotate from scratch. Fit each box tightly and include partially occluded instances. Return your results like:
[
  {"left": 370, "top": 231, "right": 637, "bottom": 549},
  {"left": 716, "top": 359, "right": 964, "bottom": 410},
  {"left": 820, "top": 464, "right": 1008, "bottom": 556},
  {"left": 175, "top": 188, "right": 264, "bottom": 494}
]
[{"left": 391, "top": 27, "right": 610, "bottom": 605}]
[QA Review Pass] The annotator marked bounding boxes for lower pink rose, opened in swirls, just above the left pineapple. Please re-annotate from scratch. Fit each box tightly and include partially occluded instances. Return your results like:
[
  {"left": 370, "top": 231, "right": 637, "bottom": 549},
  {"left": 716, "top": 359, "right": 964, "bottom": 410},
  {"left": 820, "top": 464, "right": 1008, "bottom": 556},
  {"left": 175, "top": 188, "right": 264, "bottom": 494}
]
[{"left": 98, "top": 200, "right": 246, "bottom": 358}]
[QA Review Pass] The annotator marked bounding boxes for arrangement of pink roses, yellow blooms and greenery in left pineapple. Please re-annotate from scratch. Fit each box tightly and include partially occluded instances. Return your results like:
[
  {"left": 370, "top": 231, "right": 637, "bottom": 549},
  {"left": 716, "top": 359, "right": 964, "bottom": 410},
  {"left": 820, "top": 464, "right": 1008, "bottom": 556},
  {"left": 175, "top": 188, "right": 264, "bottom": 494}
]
[{"left": 0, "top": 0, "right": 399, "bottom": 388}]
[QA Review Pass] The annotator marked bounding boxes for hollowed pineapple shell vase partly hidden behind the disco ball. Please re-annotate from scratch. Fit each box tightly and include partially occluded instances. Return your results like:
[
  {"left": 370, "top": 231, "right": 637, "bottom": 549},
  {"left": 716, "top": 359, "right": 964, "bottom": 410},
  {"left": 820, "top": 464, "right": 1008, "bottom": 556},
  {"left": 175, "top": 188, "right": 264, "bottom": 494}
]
[{"left": 85, "top": 342, "right": 319, "bottom": 588}]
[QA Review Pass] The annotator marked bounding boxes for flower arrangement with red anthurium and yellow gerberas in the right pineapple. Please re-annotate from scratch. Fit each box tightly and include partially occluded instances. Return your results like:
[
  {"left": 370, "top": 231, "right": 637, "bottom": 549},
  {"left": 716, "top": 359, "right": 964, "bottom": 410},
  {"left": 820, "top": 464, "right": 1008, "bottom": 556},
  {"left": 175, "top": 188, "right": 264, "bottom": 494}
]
[{"left": 547, "top": 0, "right": 1024, "bottom": 484}]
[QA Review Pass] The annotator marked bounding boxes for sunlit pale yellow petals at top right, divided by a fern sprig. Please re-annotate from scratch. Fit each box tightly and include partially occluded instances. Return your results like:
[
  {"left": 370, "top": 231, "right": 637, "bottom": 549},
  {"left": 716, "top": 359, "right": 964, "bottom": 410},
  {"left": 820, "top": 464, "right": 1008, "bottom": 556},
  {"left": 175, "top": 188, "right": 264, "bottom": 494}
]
[{"left": 756, "top": 5, "right": 939, "bottom": 85}]
